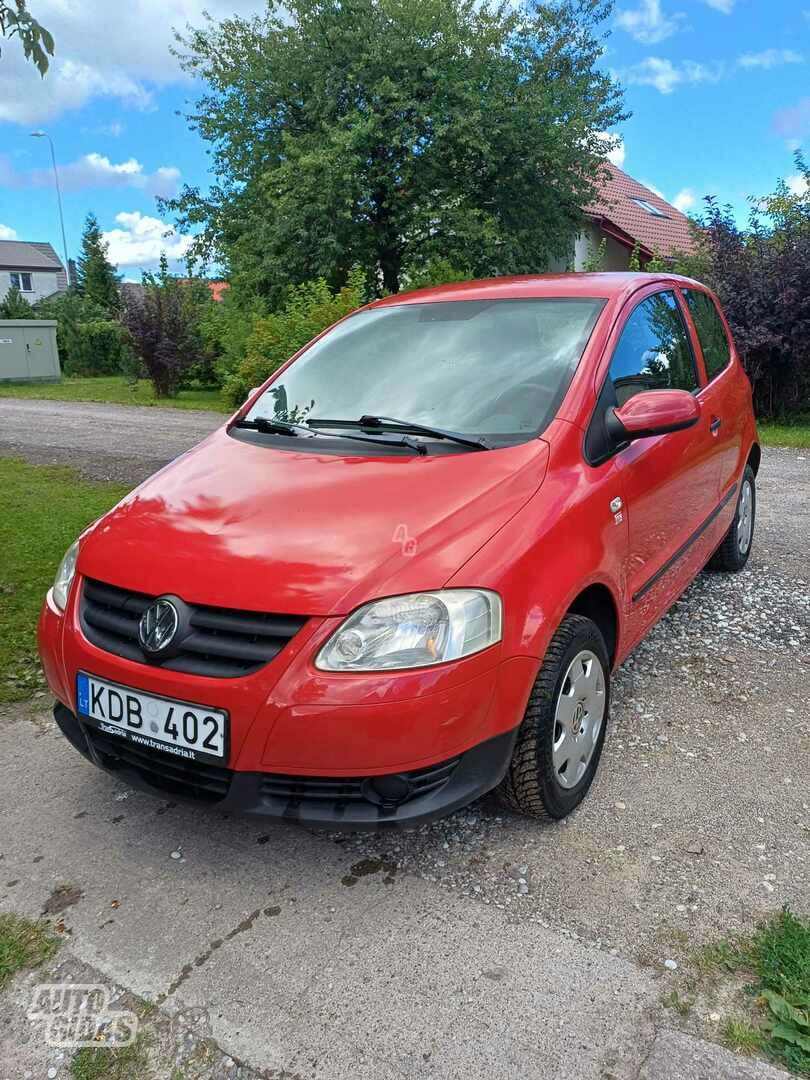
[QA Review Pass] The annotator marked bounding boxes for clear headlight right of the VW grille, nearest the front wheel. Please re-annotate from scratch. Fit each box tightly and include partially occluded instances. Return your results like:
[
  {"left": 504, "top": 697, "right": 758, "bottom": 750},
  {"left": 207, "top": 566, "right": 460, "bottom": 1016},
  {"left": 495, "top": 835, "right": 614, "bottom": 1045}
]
[{"left": 315, "top": 589, "right": 502, "bottom": 672}]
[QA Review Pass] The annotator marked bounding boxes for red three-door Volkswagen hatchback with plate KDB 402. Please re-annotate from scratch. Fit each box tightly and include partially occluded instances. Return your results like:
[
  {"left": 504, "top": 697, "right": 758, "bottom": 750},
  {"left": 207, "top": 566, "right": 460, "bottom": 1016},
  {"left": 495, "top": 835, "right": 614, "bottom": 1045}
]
[{"left": 39, "top": 273, "right": 759, "bottom": 828}]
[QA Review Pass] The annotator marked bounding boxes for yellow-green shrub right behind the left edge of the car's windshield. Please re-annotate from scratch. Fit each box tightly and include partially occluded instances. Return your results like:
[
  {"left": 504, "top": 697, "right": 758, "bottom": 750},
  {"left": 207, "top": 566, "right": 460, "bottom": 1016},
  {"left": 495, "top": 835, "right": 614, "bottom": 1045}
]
[{"left": 224, "top": 269, "right": 365, "bottom": 405}]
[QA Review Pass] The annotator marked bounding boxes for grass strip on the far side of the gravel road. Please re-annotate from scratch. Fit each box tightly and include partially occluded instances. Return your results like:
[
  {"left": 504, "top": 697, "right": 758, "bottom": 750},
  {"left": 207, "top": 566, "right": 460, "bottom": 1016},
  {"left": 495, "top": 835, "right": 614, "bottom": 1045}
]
[{"left": 0, "top": 375, "right": 233, "bottom": 413}]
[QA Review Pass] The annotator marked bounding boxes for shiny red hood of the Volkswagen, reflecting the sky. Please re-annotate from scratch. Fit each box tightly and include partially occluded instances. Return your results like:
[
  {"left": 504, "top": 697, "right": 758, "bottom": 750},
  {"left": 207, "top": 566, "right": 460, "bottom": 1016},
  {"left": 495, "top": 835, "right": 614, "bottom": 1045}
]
[{"left": 79, "top": 429, "right": 549, "bottom": 616}]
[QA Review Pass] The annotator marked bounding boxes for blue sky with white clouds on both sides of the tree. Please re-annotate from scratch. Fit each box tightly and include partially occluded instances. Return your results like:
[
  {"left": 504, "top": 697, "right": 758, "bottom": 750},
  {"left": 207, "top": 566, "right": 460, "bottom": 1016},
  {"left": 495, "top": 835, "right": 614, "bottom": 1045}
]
[{"left": 0, "top": 0, "right": 810, "bottom": 280}]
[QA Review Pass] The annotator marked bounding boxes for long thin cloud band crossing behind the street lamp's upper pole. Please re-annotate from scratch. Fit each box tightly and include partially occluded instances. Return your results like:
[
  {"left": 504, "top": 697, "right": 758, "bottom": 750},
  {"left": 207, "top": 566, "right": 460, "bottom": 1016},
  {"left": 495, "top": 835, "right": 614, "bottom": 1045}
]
[{"left": 0, "top": 151, "right": 180, "bottom": 199}]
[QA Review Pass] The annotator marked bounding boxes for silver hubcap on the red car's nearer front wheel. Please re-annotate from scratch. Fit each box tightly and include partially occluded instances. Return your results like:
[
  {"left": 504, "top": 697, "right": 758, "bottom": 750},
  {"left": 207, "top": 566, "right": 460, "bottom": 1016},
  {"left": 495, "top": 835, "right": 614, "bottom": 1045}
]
[{"left": 552, "top": 649, "right": 605, "bottom": 787}]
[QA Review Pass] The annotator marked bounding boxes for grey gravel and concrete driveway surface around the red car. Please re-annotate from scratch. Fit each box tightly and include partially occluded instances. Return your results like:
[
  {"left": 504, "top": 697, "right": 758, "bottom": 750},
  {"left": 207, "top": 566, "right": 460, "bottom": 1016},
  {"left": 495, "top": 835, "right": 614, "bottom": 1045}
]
[{"left": 0, "top": 401, "right": 810, "bottom": 1080}]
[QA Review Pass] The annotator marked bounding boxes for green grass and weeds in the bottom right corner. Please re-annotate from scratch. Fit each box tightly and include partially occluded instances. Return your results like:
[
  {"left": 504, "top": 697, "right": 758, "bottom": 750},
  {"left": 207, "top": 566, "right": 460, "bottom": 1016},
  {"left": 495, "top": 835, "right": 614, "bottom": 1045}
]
[{"left": 696, "top": 908, "right": 810, "bottom": 1077}]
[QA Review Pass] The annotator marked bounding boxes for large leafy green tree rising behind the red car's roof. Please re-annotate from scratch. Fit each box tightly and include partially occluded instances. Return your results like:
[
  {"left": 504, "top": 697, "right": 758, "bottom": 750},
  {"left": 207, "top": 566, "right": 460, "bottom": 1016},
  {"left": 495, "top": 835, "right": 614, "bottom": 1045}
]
[{"left": 163, "top": 0, "right": 624, "bottom": 302}]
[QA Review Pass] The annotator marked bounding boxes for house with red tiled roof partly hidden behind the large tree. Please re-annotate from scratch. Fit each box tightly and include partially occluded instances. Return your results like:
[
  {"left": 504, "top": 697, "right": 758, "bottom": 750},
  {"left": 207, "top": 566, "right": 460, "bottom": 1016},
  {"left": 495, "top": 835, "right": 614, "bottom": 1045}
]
[{"left": 561, "top": 162, "right": 694, "bottom": 270}]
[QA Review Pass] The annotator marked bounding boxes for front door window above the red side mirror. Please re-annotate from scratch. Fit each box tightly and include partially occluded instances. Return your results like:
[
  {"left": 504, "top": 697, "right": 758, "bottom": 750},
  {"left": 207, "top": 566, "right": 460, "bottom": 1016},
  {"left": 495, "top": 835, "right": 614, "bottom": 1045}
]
[{"left": 609, "top": 293, "right": 698, "bottom": 405}]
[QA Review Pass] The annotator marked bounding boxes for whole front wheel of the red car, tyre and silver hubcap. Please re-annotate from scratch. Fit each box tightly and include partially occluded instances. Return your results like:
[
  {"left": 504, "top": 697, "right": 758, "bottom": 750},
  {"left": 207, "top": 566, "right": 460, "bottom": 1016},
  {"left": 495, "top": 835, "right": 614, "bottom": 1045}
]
[{"left": 498, "top": 615, "right": 610, "bottom": 820}]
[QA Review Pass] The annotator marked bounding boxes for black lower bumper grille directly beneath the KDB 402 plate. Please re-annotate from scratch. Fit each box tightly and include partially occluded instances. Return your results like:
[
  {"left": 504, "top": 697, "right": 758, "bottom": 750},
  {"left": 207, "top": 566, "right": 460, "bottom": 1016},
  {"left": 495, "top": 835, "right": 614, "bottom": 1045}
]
[{"left": 84, "top": 727, "right": 233, "bottom": 802}]
